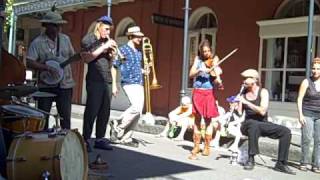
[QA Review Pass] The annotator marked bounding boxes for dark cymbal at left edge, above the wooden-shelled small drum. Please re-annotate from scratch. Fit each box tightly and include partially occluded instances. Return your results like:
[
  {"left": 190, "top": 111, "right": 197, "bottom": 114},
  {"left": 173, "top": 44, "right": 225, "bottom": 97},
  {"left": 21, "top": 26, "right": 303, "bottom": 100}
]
[{"left": 0, "top": 85, "right": 38, "bottom": 99}]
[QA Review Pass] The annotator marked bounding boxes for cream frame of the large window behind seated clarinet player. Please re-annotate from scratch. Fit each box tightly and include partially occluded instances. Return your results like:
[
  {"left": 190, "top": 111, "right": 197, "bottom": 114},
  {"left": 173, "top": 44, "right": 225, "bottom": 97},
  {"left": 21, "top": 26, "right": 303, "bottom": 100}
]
[{"left": 257, "top": 16, "right": 320, "bottom": 103}]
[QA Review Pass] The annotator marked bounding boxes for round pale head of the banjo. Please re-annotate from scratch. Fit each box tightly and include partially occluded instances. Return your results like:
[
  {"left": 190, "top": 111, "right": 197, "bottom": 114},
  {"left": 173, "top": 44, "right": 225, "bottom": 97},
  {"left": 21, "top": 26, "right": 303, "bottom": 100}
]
[{"left": 40, "top": 60, "right": 63, "bottom": 85}]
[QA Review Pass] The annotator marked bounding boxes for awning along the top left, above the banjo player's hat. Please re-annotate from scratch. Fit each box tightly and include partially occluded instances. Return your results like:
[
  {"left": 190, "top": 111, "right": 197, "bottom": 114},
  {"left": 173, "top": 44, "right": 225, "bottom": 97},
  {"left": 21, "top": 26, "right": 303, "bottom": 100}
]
[{"left": 13, "top": 0, "right": 134, "bottom": 16}]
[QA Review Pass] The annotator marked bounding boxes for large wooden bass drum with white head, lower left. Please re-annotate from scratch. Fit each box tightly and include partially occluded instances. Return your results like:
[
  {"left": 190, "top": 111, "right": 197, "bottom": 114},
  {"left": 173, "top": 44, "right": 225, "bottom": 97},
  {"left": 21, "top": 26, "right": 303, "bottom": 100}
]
[{"left": 7, "top": 130, "right": 88, "bottom": 180}]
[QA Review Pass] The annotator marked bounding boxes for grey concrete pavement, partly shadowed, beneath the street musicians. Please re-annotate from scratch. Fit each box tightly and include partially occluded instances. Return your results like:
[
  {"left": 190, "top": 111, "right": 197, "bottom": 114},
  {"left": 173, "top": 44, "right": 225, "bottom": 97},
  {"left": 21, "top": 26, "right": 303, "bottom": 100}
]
[{"left": 50, "top": 105, "right": 320, "bottom": 180}]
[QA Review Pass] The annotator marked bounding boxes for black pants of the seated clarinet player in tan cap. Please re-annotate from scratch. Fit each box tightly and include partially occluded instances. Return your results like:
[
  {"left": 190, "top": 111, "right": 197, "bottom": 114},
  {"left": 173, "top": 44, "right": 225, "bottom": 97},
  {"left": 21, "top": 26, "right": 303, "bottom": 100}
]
[{"left": 241, "top": 119, "right": 291, "bottom": 163}]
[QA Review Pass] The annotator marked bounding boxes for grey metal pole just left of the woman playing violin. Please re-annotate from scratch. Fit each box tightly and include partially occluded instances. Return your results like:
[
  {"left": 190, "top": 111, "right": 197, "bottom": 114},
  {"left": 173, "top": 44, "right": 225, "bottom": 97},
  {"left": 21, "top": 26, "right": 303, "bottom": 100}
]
[{"left": 180, "top": 0, "right": 190, "bottom": 97}]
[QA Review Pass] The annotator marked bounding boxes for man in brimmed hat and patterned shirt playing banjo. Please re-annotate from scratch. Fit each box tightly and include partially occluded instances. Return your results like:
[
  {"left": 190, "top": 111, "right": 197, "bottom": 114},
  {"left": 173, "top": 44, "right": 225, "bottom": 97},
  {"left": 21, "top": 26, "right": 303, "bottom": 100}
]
[{"left": 27, "top": 11, "right": 75, "bottom": 129}]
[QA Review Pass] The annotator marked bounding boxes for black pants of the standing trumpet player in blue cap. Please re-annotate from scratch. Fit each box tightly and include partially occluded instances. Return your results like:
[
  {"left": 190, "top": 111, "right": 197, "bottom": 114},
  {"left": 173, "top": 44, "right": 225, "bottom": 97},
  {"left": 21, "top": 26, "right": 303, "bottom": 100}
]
[{"left": 83, "top": 81, "right": 111, "bottom": 140}]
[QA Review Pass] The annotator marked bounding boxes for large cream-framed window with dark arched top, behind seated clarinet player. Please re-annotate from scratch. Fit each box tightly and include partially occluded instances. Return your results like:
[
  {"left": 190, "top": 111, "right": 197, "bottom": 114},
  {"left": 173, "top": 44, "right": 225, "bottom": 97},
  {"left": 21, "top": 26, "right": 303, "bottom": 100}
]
[{"left": 257, "top": 0, "right": 320, "bottom": 102}]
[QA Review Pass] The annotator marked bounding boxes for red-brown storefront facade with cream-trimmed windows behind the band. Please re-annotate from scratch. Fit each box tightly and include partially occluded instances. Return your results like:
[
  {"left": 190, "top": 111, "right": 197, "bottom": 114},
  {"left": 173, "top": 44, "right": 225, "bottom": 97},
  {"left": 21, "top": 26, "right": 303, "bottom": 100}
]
[{"left": 10, "top": 0, "right": 320, "bottom": 118}]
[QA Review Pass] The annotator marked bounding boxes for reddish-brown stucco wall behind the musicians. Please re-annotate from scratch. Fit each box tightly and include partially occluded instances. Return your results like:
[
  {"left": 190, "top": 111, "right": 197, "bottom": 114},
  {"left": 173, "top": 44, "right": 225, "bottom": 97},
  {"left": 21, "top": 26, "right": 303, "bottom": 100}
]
[{"left": 64, "top": 0, "right": 281, "bottom": 115}]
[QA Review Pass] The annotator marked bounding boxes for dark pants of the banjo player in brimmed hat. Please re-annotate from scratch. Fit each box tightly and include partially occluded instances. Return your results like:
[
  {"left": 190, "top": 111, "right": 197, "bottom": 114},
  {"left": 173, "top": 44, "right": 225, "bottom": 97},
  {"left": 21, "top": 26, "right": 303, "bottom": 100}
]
[{"left": 37, "top": 87, "right": 72, "bottom": 129}]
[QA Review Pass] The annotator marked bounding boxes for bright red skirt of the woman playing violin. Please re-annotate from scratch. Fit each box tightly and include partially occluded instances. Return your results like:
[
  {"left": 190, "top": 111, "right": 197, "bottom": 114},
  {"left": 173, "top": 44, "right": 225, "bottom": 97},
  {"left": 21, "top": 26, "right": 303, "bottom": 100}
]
[{"left": 192, "top": 89, "right": 219, "bottom": 120}]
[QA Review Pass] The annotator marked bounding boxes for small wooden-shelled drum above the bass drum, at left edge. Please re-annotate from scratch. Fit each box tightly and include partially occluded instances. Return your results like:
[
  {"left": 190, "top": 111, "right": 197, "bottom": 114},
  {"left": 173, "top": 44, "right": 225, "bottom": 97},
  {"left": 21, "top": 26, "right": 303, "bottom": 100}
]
[{"left": 1, "top": 104, "right": 46, "bottom": 133}]
